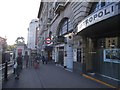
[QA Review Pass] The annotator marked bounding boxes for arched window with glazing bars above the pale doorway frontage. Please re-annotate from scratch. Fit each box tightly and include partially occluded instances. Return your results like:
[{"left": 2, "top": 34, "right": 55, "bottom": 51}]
[{"left": 58, "top": 18, "right": 73, "bottom": 36}]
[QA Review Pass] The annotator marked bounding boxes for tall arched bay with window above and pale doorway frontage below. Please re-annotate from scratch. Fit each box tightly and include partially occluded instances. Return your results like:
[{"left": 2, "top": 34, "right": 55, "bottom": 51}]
[{"left": 54, "top": 17, "right": 73, "bottom": 70}]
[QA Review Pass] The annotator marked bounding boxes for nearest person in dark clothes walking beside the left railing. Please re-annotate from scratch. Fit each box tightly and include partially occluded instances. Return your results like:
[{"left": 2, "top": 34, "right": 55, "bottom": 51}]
[{"left": 15, "top": 53, "right": 22, "bottom": 79}]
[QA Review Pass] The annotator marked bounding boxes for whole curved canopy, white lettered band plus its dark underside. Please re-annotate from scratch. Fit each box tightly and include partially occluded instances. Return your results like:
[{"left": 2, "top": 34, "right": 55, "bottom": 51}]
[{"left": 77, "top": 2, "right": 120, "bottom": 38}]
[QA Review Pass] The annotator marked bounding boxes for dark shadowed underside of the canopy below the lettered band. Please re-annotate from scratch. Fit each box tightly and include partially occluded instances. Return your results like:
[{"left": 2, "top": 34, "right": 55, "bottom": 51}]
[{"left": 78, "top": 14, "right": 120, "bottom": 38}]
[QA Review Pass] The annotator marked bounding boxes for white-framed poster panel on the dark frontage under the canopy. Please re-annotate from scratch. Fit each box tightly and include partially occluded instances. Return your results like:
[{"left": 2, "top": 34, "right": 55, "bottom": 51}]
[{"left": 103, "top": 49, "right": 120, "bottom": 63}]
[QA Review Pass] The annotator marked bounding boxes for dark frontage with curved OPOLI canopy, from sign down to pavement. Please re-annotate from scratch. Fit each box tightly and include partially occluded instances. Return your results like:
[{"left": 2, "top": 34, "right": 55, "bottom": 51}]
[{"left": 77, "top": 2, "right": 120, "bottom": 86}]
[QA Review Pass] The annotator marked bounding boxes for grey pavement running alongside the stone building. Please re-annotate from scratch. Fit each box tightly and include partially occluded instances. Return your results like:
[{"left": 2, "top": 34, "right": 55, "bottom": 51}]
[{"left": 2, "top": 63, "right": 116, "bottom": 90}]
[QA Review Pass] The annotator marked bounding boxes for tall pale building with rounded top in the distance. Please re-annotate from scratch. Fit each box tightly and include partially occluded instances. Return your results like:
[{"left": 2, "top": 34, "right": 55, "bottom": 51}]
[{"left": 27, "top": 19, "right": 39, "bottom": 55}]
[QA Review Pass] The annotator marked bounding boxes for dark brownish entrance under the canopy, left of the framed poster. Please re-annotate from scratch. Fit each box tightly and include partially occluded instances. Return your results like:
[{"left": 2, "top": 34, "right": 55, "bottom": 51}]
[{"left": 86, "top": 38, "right": 100, "bottom": 73}]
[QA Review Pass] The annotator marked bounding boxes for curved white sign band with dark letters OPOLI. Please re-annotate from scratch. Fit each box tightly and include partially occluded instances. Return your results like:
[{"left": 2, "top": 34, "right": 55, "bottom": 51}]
[{"left": 77, "top": 2, "right": 120, "bottom": 32}]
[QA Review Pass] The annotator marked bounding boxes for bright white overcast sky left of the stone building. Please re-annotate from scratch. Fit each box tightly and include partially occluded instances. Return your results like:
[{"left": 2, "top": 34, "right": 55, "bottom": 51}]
[{"left": 0, "top": 0, "right": 40, "bottom": 45}]
